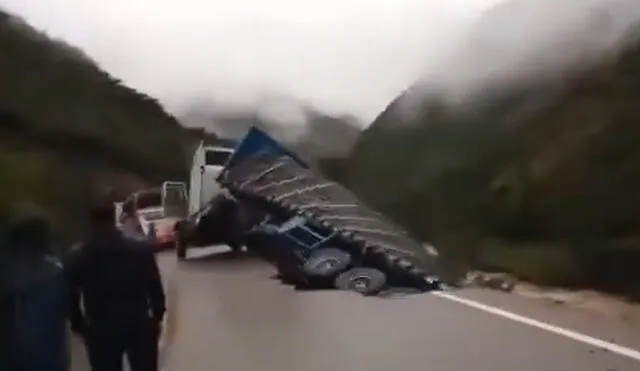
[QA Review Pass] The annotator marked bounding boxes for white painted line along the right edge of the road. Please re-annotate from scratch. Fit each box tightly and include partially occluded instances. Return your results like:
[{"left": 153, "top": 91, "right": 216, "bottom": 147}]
[{"left": 432, "top": 291, "right": 640, "bottom": 361}]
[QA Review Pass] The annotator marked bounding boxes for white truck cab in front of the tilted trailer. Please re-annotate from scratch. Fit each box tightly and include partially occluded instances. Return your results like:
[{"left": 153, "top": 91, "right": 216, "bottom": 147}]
[{"left": 189, "top": 142, "right": 234, "bottom": 215}]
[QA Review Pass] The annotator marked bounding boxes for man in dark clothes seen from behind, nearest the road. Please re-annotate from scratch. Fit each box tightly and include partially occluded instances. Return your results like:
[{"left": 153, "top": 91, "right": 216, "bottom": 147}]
[{"left": 68, "top": 203, "right": 165, "bottom": 371}]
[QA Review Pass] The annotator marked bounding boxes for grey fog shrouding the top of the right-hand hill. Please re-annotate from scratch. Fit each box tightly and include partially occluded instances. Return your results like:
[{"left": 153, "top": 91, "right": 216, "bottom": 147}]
[{"left": 406, "top": 0, "right": 640, "bottom": 107}]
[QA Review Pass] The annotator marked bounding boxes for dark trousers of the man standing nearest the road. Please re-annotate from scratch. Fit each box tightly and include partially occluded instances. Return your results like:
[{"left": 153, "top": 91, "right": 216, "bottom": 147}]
[{"left": 86, "top": 320, "right": 159, "bottom": 371}]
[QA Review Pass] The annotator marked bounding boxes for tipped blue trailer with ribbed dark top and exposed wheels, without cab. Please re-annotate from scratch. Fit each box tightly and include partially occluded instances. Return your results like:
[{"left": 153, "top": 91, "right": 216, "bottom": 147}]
[{"left": 178, "top": 128, "right": 440, "bottom": 294}]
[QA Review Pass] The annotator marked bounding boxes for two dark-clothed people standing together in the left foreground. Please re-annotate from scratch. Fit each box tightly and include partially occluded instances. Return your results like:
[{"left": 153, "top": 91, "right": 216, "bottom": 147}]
[{"left": 0, "top": 201, "right": 166, "bottom": 371}]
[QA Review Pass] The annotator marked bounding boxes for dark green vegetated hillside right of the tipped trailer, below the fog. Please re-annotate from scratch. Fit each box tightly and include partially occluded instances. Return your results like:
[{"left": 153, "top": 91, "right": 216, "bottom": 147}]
[{"left": 338, "top": 30, "right": 640, "bottom": 295}]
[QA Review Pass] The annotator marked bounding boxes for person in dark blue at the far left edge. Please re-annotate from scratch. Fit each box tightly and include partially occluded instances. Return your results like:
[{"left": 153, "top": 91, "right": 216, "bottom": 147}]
[{"left": 0, "top": 211, "right": 69, "bottom": 371}]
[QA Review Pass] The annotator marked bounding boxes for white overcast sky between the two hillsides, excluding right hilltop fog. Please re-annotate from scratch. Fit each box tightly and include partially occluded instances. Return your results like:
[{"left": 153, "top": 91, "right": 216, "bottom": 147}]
[{"left": 0, "top": 0, "right": 500, "bottom": 122}]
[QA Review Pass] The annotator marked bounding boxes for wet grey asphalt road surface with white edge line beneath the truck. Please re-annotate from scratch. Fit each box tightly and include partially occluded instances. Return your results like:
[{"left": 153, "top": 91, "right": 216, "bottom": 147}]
[{"left": 74, "top": 247, "right": 640, "bottom": 371}]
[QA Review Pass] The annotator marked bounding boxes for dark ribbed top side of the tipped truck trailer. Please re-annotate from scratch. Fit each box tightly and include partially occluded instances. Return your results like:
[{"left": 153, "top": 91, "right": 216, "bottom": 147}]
[{"left": 218, "top": 153, "right": 429, "bottom": 265}]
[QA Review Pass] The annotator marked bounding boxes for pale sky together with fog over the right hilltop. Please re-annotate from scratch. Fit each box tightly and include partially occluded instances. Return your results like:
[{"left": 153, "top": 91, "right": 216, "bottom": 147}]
[{"left": 0, "top": 0, "right": 640, "bottom": 125}]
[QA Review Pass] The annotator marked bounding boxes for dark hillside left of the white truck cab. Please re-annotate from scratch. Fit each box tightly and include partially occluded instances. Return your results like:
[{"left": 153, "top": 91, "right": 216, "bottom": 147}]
[{"left": 0, "top": 12, "right": 198, "bottom": 243}]
